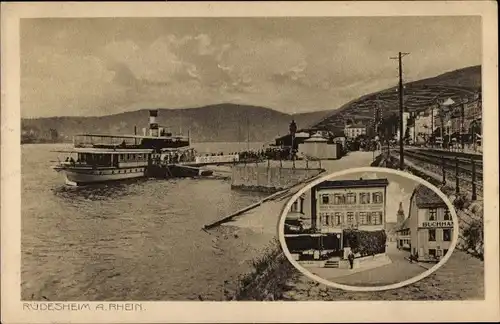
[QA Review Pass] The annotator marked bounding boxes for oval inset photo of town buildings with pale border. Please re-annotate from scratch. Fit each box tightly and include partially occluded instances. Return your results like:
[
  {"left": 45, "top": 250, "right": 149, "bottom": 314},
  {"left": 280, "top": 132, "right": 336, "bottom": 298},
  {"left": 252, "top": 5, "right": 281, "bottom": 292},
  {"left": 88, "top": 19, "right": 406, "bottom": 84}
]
[{"left": 279, "top": 167, "right": 458, "bottom": 291}]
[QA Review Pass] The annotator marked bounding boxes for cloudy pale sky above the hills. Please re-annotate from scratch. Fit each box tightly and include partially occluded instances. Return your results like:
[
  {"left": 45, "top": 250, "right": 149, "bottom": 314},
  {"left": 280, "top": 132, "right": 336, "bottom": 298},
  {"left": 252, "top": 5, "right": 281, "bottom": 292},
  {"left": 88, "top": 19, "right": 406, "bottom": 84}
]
[{"left": 21, "top": 16, "right": 481, "bottom": 118}]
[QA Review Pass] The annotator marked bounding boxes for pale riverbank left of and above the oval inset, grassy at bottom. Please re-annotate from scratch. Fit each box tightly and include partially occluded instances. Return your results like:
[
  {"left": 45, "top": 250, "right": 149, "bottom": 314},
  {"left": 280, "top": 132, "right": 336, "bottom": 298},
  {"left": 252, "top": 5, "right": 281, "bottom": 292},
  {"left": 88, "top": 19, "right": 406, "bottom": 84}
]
[{"left": 207, "top": 152, "right": 373, "bottom": 300}]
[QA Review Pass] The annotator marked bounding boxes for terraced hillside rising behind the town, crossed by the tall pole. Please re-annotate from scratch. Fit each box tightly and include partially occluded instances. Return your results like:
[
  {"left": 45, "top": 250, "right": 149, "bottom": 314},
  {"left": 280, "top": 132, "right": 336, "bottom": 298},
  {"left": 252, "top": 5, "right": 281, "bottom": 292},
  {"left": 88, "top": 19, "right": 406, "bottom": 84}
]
[{"left": 314, "top": 66, "right": 481, "bottom": 130}]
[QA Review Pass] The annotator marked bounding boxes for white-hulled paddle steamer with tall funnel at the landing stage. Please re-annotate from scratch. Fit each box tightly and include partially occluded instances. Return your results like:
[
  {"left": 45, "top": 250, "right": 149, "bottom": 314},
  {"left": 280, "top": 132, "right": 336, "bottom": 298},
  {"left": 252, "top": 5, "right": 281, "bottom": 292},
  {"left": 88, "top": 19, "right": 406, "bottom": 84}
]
[{"left": 53, "top": 110, "right": 195, "bottom": 186}]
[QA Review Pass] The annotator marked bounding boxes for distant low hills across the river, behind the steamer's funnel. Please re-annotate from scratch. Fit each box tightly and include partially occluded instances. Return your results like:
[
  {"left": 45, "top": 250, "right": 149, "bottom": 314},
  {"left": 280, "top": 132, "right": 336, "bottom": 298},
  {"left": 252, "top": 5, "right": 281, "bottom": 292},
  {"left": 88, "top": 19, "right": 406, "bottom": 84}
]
[{"left": 21, "top": 103, "right": 329, "bottom": 142}]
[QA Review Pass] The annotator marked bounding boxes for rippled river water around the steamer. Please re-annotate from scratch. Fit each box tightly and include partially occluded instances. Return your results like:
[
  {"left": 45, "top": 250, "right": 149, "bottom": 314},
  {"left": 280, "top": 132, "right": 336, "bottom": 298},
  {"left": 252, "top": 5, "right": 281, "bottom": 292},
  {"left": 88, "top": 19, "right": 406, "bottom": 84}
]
[{"left": 21, "top": 143, "right": 270, "bottom": 301}]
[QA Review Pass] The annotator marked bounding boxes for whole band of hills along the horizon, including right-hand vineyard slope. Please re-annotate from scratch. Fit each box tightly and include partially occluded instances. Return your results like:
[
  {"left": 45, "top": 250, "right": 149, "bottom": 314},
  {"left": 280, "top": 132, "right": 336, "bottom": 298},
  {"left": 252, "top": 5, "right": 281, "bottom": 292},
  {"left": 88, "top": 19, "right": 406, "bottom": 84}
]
[{"left": 21, "top": 66, "right": 481, "bottom": 142}]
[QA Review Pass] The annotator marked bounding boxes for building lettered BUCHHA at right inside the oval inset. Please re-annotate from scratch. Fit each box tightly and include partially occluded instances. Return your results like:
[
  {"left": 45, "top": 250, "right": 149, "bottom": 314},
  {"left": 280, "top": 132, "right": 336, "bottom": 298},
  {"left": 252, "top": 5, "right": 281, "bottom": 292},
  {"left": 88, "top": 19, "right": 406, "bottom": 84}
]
[{"left": 408, "top": 185, "right": 453, "bottom": 262}]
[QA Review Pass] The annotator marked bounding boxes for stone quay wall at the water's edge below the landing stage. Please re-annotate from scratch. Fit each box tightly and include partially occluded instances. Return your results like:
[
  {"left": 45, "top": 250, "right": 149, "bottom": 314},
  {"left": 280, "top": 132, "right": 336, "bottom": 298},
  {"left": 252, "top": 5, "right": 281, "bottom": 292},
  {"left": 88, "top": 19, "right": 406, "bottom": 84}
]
[{"left": 231, "top": 164, "right": 324, "bottom": 192}]
